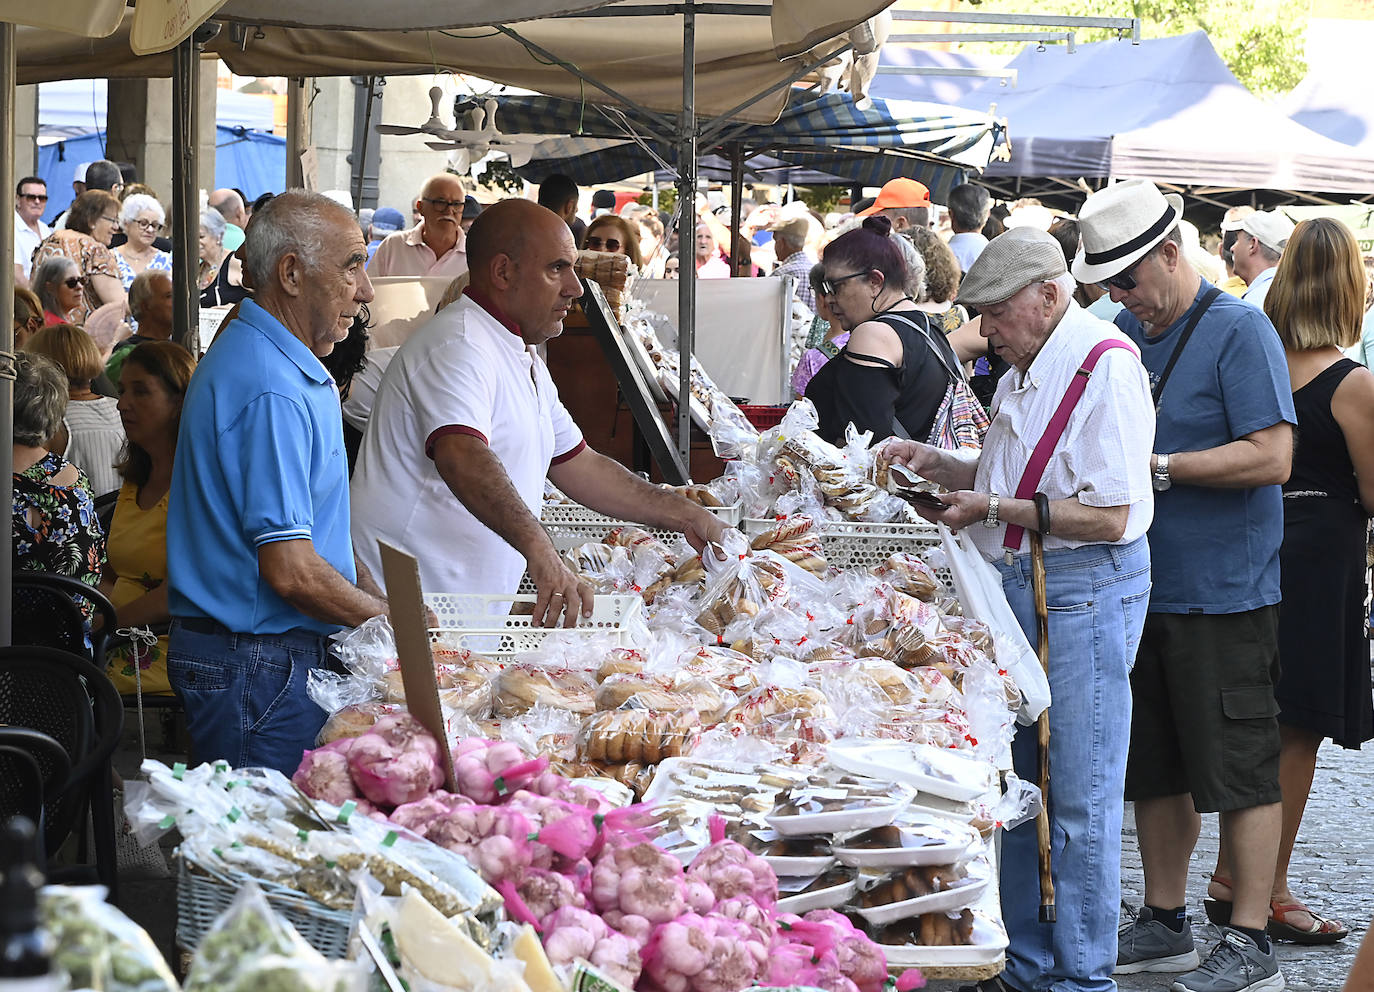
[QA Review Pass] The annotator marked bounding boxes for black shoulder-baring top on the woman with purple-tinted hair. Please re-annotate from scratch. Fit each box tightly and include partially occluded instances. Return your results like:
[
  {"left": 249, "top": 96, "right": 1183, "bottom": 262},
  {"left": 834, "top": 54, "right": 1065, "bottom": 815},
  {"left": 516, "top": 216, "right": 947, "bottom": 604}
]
[{"left": 807, "top": 311, "right": 959, "bottom": 445}]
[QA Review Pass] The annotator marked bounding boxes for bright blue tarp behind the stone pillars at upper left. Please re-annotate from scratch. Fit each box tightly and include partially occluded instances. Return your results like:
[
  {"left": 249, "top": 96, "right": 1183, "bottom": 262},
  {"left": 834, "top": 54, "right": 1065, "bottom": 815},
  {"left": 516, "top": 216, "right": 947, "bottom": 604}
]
[{"left": 38, "top": 126, "right": 286, "bottom": 221}]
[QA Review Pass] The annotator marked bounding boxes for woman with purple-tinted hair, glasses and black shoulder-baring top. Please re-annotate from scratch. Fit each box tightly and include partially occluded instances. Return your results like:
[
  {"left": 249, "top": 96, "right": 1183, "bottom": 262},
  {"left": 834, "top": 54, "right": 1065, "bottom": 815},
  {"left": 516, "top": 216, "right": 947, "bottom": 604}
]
[{"left": 807, "top": 214, "right": 962, "bottom": 444}]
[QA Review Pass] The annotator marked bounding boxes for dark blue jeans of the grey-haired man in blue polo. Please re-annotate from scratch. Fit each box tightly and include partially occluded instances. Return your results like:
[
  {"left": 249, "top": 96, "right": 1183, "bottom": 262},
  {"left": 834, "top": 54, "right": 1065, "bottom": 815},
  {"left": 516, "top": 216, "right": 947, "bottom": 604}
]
[{"left": 168, "top": 620, "right": 328, "bottom": 775}]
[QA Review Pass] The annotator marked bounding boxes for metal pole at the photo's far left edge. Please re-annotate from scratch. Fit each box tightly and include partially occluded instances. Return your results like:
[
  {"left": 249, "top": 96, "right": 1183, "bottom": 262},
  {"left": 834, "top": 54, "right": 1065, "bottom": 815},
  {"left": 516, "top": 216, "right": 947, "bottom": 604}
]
[{"left": 0, "top": 22, "right": 18, "bottom": 647}]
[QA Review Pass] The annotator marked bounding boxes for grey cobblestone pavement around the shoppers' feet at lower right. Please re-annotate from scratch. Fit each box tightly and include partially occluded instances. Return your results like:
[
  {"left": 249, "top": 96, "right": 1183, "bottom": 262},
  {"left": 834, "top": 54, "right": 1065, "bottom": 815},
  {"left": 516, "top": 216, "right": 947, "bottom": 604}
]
[{"left": 929, "top": 743, "right": 1374, "bottom": 992}]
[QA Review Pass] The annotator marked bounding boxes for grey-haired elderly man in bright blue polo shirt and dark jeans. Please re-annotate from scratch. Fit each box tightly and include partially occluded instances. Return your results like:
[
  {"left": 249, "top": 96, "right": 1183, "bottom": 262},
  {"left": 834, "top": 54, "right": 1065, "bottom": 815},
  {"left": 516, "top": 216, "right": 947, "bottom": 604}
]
[{"left": 168, "top": 190, "right": 386, "bottom": 774}]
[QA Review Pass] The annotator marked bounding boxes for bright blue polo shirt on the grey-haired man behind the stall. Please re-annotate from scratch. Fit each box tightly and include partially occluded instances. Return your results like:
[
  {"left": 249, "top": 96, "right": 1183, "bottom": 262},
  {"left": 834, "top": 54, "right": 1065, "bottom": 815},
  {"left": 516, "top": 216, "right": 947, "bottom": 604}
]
[{"left": 168, "top": 300, "right": 357, "bottom": 633}]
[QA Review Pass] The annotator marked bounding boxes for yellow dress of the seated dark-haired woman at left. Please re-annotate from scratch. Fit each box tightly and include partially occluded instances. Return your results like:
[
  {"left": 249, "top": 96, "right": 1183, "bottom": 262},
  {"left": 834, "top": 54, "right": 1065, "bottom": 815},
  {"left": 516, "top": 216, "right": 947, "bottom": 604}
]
[{"left": 106, "top": 482, "right": 172, "bottom": 694}]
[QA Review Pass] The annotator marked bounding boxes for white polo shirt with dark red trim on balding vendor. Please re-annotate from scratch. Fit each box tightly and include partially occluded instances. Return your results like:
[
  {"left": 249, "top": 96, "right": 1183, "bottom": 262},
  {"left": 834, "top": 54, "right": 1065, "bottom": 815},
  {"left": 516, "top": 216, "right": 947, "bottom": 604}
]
[{"left": 352, "top": 290, "right": 587, "bottom": 595}]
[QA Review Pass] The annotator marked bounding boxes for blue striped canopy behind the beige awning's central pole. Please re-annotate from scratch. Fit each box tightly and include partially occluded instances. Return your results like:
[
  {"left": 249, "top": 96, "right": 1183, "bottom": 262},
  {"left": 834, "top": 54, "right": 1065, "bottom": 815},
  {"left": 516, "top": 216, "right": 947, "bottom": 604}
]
[{"left": 497, "top": 91, "right": 1000, "bottom": 198}]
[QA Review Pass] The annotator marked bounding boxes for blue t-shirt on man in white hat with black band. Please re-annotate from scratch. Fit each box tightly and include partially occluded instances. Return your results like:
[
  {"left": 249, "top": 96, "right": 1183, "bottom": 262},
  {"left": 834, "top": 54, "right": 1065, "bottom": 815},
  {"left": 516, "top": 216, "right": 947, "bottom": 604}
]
[{"left": 1116, "top": 279, "right": 1297, "bottom": 613}]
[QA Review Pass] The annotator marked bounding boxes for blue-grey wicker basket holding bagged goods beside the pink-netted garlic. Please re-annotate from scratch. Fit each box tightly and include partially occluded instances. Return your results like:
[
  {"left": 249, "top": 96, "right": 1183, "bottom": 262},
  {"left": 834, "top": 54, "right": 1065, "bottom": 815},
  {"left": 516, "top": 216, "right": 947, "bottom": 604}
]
[{"left": 176, "top": 856, "right": 353, "bottom": 959}]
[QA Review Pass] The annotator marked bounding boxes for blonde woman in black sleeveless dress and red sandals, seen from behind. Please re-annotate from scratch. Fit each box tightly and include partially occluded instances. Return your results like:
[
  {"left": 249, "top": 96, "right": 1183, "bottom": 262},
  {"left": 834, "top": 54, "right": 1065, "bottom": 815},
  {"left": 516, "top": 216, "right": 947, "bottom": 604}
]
[{"left": 1216, "top": 217, "right": 1374, "bottom": 944}]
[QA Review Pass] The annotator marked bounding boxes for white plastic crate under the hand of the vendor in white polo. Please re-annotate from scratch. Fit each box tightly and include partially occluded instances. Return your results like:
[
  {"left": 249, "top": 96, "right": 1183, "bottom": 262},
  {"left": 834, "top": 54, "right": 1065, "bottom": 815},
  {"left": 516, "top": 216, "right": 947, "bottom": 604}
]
[{"left": 425, "top": 592, "right": 647, "bottom": 655}]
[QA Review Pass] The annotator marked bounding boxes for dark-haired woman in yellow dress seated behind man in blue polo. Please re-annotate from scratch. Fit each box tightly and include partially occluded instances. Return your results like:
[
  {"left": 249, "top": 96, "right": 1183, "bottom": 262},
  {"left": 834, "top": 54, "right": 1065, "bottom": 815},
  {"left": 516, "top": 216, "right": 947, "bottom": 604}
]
[{"left": 100, "top": 341, "right": 195, "bottom": 692}]
